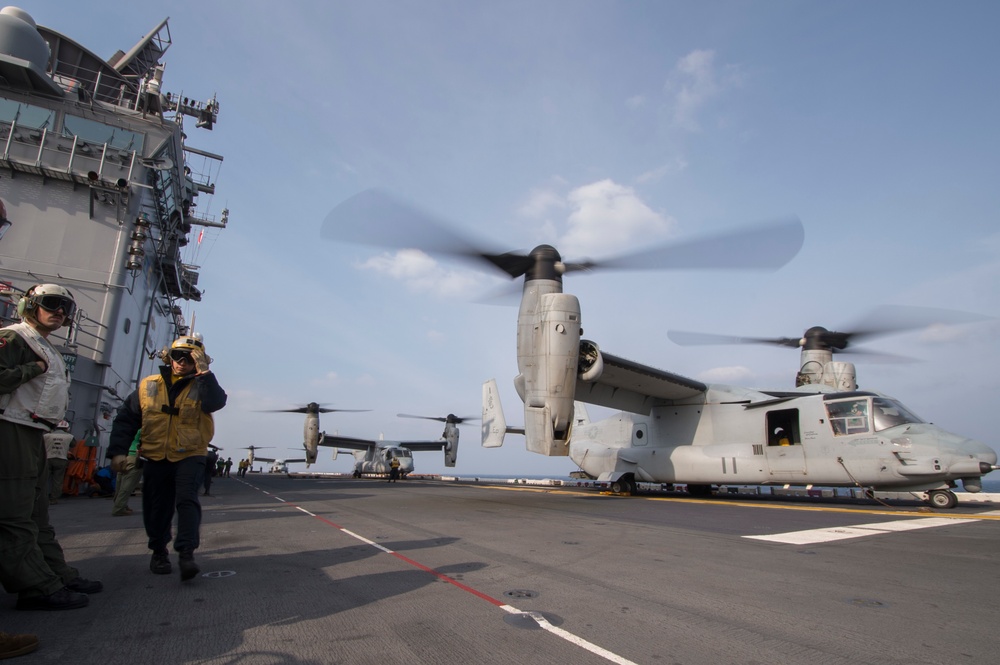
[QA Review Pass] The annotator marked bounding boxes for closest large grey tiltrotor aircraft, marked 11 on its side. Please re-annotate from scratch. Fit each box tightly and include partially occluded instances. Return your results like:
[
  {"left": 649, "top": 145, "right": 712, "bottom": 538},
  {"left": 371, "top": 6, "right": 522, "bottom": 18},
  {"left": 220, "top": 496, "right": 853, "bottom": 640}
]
[{"left": 323, "top": 190, "right": 998, "bottom": 508}]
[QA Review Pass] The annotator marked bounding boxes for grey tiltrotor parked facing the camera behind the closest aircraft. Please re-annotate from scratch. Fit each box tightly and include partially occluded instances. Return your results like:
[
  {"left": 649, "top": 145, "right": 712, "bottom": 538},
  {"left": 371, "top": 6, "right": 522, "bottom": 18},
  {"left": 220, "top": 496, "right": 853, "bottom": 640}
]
[{"left": 320, "top": 413, "right": 472, "bottom": 478}]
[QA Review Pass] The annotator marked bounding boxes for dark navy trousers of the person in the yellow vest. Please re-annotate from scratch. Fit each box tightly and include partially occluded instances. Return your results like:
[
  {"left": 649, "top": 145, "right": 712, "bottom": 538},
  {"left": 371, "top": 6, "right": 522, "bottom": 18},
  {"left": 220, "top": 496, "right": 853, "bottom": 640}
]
[{"left": 142, "top": 455, "right": 205, "bottom": 552}]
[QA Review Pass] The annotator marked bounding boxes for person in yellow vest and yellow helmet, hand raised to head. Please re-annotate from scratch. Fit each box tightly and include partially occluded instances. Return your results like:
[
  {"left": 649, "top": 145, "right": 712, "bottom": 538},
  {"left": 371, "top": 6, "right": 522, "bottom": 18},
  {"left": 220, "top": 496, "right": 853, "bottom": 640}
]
[{"left": 108, "top": 335, "right": 227, "bottom": 581}]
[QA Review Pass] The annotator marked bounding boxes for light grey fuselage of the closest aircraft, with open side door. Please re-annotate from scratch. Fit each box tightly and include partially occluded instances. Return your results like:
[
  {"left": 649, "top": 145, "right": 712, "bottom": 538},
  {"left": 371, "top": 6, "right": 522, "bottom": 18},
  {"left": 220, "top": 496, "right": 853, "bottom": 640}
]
[{"left": 569, "top": 386, "right": 997, "bottom": 491}]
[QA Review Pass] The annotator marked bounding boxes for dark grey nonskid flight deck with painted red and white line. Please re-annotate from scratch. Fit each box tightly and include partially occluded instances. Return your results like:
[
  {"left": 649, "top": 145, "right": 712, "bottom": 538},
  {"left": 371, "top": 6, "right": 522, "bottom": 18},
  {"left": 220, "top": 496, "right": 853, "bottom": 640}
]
[{"left": 0, "top": 475, "right": 1000, "bottom": 665}]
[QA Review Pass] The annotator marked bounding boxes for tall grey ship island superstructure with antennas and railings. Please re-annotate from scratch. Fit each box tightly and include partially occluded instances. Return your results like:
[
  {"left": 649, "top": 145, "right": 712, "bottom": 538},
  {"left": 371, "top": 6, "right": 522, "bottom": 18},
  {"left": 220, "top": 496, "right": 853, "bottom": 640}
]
[{"left": 0, "top": 7, "right": 228, "bottom": 454}]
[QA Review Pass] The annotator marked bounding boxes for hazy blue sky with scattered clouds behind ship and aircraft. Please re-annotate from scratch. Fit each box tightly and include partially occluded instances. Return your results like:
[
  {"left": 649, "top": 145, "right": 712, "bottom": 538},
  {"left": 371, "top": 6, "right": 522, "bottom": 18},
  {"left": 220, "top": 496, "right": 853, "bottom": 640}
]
[{"left": 33, "top": 0, "right": 1000, "bottom": 475}]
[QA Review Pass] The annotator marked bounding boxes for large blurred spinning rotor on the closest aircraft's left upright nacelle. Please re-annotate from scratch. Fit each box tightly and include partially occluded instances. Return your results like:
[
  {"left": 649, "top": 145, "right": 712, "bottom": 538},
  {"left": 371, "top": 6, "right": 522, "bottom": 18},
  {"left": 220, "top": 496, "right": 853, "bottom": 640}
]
[{"left": 321, "top": 190, "right": 805, "bottom": 278}]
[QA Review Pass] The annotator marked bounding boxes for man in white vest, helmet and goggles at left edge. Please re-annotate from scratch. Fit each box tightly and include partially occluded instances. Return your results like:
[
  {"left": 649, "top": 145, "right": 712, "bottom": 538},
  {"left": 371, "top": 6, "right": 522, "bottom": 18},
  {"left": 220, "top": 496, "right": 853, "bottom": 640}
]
[{"left": 0, "top": 284, "right": 103, "bottom": 610}]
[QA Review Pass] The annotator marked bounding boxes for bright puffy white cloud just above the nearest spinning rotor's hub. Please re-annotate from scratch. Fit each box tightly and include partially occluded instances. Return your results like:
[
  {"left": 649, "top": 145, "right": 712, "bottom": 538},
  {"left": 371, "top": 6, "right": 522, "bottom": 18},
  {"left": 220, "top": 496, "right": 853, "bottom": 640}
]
[{"left": 559, "top": 179, "right": 675, "bottom": 258}]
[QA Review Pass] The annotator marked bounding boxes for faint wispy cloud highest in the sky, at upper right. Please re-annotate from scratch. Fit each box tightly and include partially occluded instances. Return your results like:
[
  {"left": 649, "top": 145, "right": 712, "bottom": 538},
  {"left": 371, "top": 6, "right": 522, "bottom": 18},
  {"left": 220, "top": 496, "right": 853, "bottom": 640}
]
[{"left": 665, "top": 50, "right": 741, "bottom": 132}]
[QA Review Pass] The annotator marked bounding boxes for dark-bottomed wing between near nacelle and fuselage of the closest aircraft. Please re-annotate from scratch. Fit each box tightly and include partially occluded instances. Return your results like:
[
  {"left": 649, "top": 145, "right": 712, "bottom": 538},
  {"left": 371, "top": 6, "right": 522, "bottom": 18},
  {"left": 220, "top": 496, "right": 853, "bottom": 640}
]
[{"left": 576, "top": 351, "right": 708, "bottom": 415}]
